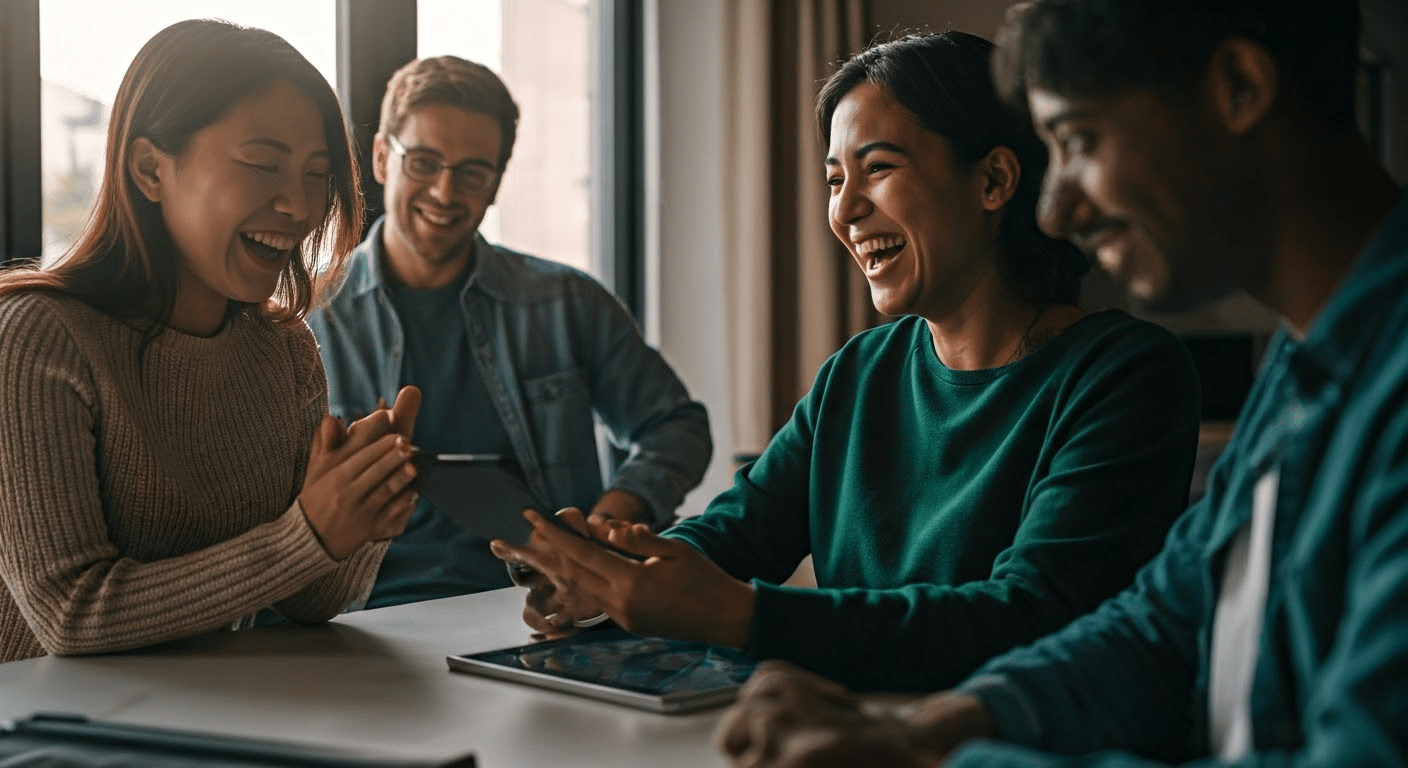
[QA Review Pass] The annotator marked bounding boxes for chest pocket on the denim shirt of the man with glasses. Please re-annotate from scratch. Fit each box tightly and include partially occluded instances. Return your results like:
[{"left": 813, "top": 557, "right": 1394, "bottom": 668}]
[{"left": 522, "top": 368, "right": 597, "bottom": 465}]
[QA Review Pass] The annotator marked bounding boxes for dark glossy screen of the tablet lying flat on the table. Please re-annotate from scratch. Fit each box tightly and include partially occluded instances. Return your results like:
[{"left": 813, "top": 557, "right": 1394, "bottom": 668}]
[{"left": 465, "top": 628, "right": 756, "bottom": 696}]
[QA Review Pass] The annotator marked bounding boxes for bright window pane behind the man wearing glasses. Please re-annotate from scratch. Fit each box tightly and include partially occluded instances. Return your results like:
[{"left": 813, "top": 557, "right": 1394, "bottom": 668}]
[{"left": 417, "top": 0, "right": 593, "bottom": 271}]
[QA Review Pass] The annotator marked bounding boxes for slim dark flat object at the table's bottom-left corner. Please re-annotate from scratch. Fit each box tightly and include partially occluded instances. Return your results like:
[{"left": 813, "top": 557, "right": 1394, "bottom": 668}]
[{"left": 0, "top": 713, "right": 474, "bottom": 768}]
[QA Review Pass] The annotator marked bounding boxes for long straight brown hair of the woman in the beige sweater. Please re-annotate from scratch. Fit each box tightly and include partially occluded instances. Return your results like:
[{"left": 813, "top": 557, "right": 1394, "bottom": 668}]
[{"left": 0, "top": 20, "right": 363, "bottom": 331}]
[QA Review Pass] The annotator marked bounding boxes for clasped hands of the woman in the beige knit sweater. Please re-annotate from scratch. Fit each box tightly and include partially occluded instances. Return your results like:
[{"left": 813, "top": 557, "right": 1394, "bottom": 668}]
[{"left": 298, "top": 386, "right": 421, "bottom": 559}]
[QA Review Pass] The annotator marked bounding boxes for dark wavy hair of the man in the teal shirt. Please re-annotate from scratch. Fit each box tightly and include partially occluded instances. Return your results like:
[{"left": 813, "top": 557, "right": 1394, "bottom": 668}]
[{"left": 994, "top": 0, "right": 1362, "bottom": 132}]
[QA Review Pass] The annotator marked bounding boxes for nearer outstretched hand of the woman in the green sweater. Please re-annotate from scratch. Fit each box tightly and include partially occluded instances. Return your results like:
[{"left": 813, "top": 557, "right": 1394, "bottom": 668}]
[{"left": 490, "top": 510, "right": 755, "bottom": 648}]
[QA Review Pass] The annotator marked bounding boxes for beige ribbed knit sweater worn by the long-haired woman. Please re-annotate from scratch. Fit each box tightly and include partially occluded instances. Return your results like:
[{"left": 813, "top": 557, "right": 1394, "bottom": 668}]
[{"left": 0, "top": 293, "right": 386, "bottom": 661}]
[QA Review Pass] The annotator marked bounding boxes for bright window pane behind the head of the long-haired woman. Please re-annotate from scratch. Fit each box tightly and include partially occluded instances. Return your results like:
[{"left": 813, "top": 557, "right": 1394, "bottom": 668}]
[{"left": 39, "top": 0, "right": 337, "bottom": 262}]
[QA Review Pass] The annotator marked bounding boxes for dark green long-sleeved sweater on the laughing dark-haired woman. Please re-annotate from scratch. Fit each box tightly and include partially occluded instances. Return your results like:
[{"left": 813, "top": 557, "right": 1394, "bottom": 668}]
[{"left": 667, "top": 311, "right": 1198, "bottom": 690}]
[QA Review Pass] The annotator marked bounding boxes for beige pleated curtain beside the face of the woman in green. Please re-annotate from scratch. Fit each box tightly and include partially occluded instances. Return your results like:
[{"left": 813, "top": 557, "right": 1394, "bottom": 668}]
[{"left": 724, "top": 0, "right": 877, "bottom": 457}]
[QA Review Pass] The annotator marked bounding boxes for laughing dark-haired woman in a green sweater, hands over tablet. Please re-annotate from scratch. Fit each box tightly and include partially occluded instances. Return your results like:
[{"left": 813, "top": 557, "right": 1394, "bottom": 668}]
[{"left": 494, "top": 32, "right": 1198, "bottom": 690}]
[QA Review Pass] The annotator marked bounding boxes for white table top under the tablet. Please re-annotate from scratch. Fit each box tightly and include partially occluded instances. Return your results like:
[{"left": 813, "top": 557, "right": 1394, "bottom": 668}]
[{"left": 0, "top": 588, "right": 724, "bottom": 768}]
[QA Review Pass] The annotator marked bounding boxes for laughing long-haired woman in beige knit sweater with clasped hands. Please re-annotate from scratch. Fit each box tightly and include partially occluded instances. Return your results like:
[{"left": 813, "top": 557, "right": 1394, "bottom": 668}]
[{"left": 0, "top": 21, "right": 420, "bottom": 661}]
